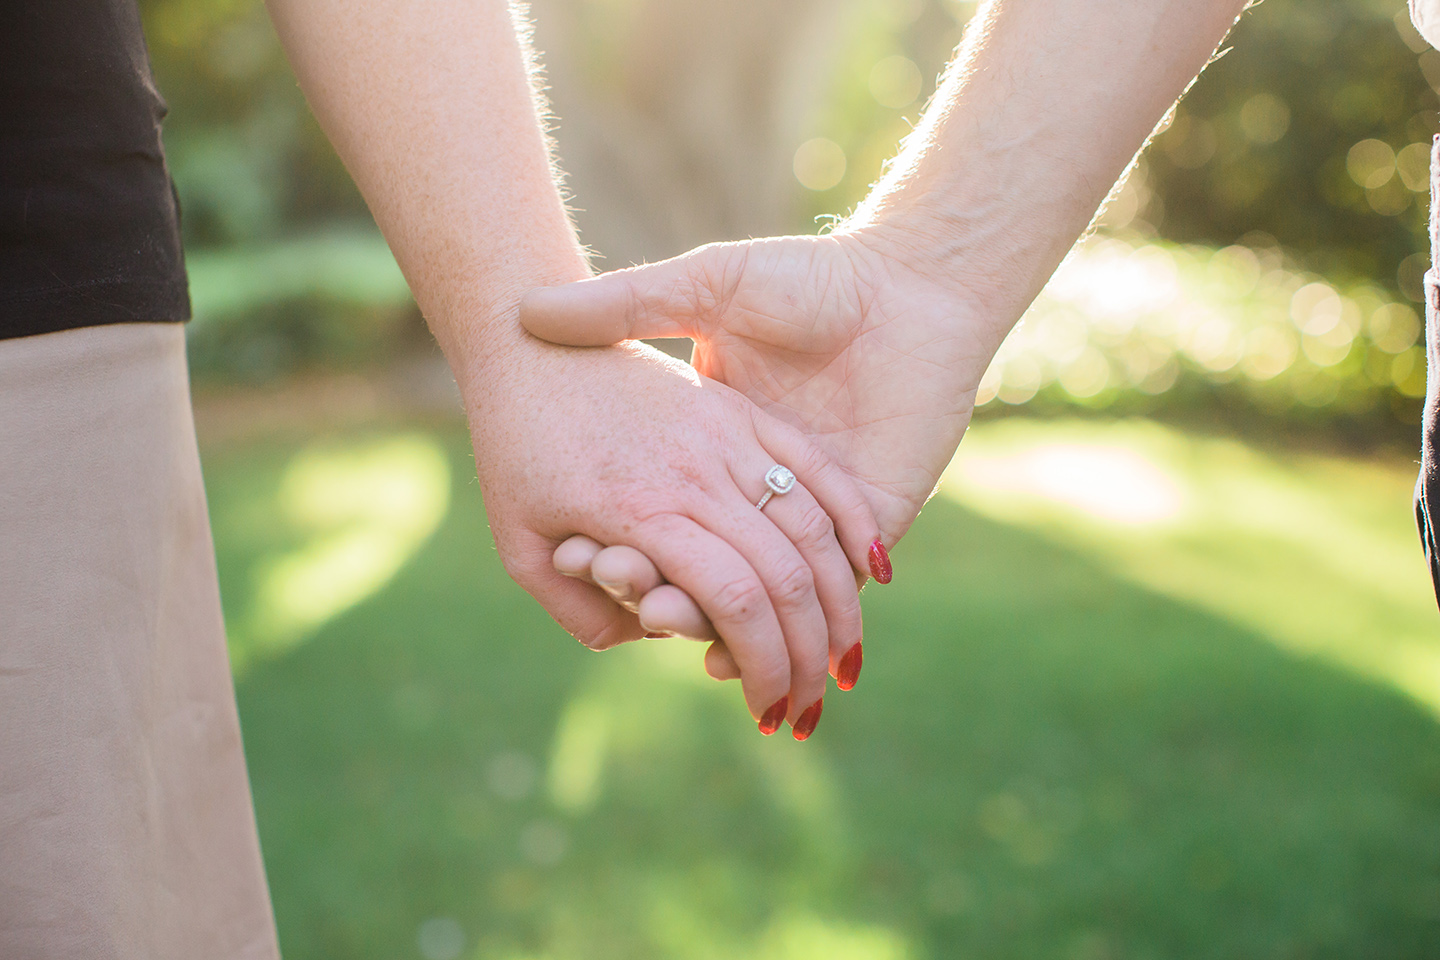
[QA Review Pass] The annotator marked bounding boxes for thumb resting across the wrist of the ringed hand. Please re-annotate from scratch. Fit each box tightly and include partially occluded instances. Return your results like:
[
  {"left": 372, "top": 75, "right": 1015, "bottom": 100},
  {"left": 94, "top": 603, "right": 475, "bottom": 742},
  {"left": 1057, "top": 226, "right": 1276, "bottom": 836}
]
[{"left": 520, "top": 255, "right": 714, "bottom": 347}]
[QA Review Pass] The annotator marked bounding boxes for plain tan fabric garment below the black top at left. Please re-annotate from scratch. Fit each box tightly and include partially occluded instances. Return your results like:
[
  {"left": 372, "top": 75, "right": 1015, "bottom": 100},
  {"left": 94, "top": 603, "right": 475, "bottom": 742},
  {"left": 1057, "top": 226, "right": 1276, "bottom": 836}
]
[{"left": 0, "top": 324, "right": 278, "bottom": 960}]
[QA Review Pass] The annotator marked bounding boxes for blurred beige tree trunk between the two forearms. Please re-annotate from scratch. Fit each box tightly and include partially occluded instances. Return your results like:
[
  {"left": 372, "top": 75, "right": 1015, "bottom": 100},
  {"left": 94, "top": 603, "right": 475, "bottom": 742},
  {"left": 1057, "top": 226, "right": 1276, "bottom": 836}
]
[{"left": 534, "top": 0, "right": 854, "bottom": 269}]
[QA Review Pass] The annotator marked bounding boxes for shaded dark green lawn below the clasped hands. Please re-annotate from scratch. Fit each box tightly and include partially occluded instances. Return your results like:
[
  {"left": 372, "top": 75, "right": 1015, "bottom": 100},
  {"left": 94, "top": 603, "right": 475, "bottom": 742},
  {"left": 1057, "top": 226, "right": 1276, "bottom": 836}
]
[{"left": 212, "top": 432, "right": 1440, "bottom": 960}]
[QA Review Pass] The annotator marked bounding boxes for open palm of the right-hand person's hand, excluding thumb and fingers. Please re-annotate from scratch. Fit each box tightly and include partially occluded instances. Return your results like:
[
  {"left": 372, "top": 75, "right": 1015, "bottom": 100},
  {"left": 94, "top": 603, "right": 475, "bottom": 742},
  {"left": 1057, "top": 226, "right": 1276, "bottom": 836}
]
[{"left": 676, "top": 236, "right": 994, "bottom": 543}]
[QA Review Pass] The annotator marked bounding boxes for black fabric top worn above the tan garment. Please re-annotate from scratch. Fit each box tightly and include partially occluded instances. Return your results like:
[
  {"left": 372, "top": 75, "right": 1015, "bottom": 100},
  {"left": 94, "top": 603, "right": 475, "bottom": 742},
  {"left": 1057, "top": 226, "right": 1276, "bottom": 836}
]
[{"left": 0, "top": 0, "right": 190, "bottom": 337}]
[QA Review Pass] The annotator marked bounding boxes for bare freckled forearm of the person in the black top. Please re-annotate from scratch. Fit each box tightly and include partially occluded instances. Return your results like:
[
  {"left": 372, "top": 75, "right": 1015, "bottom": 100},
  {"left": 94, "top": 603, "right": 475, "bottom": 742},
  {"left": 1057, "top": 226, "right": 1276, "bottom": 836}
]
[{"left": 268, "top": 0, "right": 588, "bottom": 387}]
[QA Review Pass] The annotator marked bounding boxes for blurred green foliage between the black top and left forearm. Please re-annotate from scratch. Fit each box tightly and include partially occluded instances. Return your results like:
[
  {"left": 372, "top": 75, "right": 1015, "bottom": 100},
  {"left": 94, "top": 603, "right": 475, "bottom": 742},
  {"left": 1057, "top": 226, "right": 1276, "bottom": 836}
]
[{"left": 141, "top": 0, "right": 426, "bottom": 381}]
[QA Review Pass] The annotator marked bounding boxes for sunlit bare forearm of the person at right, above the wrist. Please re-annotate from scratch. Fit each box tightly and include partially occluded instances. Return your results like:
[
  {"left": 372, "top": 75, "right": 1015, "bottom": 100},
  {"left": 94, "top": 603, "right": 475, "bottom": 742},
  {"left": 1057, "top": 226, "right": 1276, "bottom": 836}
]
[{"left": 851, "top": 0, "right": 1247, "bottom": 345}]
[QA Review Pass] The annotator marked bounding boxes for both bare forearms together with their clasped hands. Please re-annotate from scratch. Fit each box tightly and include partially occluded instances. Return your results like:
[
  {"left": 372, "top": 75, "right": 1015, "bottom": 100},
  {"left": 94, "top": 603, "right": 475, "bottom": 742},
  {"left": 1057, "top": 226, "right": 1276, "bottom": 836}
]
[{"left": 269, "top": 0, "right": 1247, "bottom": 737}]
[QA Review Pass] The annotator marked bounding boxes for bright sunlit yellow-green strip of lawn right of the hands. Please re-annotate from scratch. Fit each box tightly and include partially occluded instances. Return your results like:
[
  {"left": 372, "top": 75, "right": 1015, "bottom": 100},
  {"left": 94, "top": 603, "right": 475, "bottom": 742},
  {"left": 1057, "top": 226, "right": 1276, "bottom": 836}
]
[{"left": 940, "top": 420, "right": 1440, "bottom": 715}]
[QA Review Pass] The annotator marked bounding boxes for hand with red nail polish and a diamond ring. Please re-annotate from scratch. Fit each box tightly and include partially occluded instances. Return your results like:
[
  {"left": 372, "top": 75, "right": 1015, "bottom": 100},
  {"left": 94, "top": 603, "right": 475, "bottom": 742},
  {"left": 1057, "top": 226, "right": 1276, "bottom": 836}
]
[{"left": 462, "top": 333, "right": 878, "bottom": 733}]
